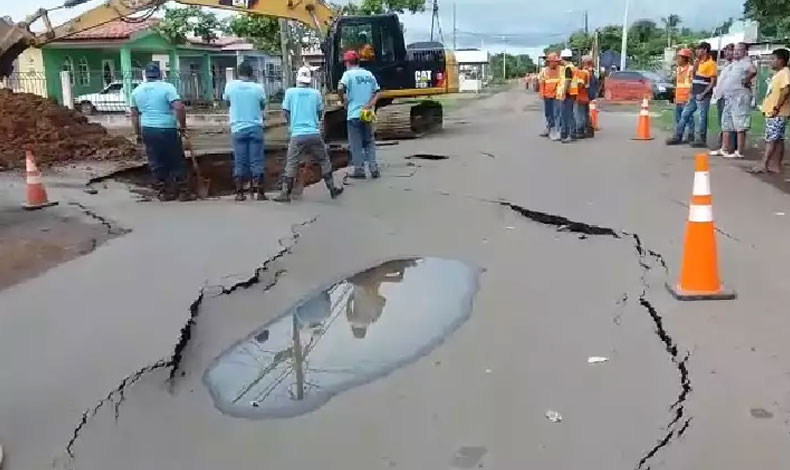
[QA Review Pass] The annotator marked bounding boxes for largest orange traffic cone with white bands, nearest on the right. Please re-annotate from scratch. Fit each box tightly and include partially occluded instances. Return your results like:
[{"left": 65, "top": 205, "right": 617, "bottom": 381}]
[{"left": 667, "top": 153, "right": 736, "bottom": 300}]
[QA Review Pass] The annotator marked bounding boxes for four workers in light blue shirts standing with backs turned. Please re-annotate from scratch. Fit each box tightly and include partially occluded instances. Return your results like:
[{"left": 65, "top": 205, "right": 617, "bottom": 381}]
[{"left": 131, "top": 50, "right": 380, "bottom": 202}]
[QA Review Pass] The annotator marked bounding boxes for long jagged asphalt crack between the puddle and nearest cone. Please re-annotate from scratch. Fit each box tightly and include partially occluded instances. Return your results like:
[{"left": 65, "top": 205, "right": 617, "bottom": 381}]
[{"left": 508, "top": 201, "right": 692, "bottom": 470}]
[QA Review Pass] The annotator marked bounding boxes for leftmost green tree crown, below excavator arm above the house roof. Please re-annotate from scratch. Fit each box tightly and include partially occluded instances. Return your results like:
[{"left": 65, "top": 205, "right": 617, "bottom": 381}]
[{"left": 154, "top": 6, "right": 224, "bottom": 44}]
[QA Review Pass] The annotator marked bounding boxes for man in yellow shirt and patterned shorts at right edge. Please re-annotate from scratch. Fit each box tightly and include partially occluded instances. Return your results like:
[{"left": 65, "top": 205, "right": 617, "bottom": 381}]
[{"left": 752, "top": 49, "right": 790, "bottom": 174}]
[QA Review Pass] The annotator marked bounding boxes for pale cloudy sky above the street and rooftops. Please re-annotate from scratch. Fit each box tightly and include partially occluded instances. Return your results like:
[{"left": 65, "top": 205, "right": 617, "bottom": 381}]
[{"left": 6, "top": 0, "right": 743, "bottom": 55}]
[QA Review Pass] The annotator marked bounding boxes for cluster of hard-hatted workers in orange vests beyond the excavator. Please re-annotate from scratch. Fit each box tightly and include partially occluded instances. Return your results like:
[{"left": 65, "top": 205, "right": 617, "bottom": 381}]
[{"left": 538, "top": 50, "right": 598, "bottom": 143}]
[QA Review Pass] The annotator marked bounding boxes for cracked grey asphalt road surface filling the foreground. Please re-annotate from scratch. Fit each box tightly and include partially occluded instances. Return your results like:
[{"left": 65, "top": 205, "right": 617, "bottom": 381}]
[{"left": 0, "top": 90, "right": 790, "bottom": 470}]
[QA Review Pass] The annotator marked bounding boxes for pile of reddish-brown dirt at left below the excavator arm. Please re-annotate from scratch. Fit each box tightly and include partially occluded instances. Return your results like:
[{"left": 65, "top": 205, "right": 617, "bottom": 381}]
[{"left": 0, "top": 89, "right": 141, "bottom": 170}]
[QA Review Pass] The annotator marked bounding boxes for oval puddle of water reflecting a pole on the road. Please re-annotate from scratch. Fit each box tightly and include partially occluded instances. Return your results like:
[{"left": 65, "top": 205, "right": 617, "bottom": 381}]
[{"left": 203, "top": 258, "right": 480, "bottom": 419}]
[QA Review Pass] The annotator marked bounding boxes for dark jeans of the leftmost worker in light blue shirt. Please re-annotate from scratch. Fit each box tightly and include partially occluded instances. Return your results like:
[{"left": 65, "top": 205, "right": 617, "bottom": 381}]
[{"left": 141, "top": 127, "right": 187, "bottom": 183}]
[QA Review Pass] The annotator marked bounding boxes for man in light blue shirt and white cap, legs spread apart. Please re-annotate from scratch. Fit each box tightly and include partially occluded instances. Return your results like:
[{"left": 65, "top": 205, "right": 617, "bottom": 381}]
[{"left": 274, "top": 67, "right": 343, "bottom": 202}]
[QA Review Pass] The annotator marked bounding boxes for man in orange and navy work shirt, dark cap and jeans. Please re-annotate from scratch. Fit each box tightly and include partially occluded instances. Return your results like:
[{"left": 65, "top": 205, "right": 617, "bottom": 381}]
[{"left": 667, "top": 42, "right": 717, "bottom": 148}]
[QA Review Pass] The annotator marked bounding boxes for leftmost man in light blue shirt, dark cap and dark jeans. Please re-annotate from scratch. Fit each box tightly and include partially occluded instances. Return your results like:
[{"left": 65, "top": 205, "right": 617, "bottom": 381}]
[{"left": 131, "top": 63, "right": 195, "bottom": 201}]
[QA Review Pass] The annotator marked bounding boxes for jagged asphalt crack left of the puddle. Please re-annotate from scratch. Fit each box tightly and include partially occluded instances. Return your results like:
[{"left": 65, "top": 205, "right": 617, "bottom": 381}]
[{"left": 66, "top": 217, "right": 318, "bottom": 459}]
